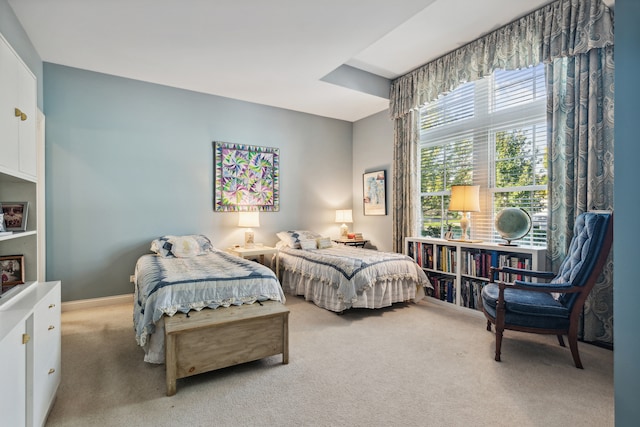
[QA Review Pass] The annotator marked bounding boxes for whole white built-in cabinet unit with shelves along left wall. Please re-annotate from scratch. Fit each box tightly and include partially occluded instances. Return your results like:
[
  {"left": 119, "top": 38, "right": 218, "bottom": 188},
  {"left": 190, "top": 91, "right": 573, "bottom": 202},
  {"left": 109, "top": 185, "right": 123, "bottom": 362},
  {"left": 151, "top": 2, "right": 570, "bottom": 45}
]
[{"left": 0, "top": 30, "right": 61, "bottom": 427}]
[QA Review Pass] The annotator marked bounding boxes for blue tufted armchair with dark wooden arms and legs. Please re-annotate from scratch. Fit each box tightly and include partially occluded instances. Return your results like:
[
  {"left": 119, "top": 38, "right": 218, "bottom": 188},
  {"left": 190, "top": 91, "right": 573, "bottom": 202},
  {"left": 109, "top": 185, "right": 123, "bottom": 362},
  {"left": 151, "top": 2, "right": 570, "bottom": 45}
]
[{"left": 481, "top": 211, "right": 613, "bottom": 369}]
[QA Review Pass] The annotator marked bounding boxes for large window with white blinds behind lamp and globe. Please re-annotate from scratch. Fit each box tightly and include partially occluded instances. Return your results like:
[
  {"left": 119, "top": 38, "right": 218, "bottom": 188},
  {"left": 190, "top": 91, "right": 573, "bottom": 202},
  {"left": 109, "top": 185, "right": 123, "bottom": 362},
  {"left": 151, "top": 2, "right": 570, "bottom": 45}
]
[{"left": 419, "top": 64, "right": 548, "bottom": 246}]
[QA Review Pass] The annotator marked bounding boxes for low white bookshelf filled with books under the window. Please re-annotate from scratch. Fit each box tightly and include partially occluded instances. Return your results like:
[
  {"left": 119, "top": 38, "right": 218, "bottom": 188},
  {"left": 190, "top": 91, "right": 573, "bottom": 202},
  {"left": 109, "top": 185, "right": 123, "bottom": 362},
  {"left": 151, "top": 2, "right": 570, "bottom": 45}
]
[{"left": 404, "top": 237, "right": 547, "bottom": 310}]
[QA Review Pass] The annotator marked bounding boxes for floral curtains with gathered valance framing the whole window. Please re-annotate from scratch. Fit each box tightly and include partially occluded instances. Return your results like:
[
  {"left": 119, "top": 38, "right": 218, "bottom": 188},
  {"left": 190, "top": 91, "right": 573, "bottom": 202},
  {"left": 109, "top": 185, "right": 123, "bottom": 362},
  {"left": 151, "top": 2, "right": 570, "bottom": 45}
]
[{"left": 389, "top": 0, "right": 614, "bottom": 339}]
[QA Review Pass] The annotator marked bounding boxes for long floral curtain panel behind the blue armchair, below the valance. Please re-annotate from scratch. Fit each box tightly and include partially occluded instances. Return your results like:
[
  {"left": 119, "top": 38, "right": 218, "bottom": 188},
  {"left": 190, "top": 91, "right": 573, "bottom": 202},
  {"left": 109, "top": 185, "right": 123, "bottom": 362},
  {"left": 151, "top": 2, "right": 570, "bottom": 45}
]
[{"left": 546, "top": 46, "right": 614, "bottom": 345}]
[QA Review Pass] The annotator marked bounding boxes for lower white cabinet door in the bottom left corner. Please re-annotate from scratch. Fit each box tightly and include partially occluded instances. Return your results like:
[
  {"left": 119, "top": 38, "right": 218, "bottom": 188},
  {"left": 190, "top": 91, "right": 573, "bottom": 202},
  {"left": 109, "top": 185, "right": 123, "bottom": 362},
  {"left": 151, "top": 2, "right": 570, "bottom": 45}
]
[{"left": 0, "top": 321, "right": 27, "bottom": 426}]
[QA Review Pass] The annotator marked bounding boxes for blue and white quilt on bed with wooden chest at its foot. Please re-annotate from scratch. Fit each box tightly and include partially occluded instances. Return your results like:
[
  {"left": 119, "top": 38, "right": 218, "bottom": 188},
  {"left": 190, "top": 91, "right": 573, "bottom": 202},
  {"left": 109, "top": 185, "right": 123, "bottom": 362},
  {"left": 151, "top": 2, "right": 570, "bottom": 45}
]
[{"left": 133, "top": 249, "right": 285, "bottom": 363}]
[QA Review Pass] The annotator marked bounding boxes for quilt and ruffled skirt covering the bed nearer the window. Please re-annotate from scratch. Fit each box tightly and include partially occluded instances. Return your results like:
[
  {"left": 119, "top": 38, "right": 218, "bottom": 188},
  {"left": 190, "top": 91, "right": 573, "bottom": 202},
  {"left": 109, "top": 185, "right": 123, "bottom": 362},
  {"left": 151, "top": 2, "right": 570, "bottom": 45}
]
[{"left": 278, "top": 245, "right": 432, "bottom": 312}]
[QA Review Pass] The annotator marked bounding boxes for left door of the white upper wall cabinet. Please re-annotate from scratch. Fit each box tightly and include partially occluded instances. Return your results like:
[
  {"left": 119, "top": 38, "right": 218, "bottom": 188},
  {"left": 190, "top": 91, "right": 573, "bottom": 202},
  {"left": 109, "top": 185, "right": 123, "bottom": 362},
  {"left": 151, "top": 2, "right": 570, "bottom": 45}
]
[{"left": 0, "top": 37, "right": 20, "bottom": 170}]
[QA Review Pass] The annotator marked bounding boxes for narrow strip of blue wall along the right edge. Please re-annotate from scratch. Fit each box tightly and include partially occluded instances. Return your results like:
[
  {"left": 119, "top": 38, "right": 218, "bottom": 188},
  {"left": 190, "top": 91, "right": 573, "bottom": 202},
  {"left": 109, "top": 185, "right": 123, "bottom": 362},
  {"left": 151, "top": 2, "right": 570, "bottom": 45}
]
[{"left": 613, "top": 0, "right": 640, "bottom": 427}]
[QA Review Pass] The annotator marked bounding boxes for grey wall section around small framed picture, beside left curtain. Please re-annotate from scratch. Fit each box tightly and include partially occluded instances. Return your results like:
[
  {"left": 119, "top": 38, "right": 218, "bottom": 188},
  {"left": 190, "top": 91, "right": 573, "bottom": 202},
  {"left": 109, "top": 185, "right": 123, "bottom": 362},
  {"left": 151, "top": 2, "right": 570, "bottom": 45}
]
[{"left": 352, "top": 110, "right": 393, "bottom": 251}]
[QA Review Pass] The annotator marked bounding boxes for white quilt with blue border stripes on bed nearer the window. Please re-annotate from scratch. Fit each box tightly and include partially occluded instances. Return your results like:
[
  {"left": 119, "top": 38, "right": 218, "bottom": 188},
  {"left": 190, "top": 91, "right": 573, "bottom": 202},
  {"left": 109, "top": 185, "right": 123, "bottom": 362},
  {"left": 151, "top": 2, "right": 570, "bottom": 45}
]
[{"left": 279, "top": 245, "right": 431, "bottom": 308}]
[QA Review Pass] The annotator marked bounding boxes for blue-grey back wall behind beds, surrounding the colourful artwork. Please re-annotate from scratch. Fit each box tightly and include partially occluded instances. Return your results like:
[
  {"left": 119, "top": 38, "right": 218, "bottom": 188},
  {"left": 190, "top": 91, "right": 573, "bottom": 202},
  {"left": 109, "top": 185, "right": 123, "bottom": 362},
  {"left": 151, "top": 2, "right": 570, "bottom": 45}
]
[{"left": 44, "top": 63, "right": 352, "bottom": 301}]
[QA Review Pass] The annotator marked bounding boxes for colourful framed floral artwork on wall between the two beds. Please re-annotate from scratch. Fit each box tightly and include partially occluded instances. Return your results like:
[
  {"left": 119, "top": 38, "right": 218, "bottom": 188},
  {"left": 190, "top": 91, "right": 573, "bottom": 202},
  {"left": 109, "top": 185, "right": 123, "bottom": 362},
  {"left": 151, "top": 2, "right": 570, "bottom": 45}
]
[{"left": 213, "top": 141, "right": 280, "bottom": 212}]
